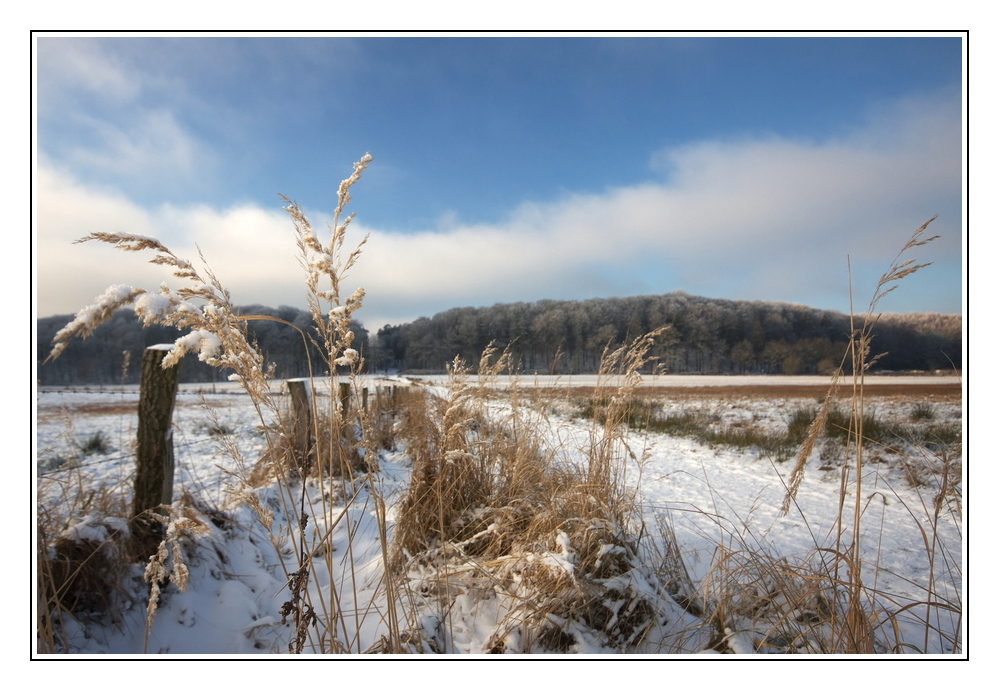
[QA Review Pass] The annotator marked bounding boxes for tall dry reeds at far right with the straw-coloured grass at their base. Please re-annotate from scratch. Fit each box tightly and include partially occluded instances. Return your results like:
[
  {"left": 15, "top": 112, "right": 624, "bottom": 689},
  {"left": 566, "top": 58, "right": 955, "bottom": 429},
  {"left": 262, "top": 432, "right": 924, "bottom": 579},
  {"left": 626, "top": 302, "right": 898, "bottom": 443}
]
[{"left": 652, "top": 219, "right": 961, "bottom": 654}]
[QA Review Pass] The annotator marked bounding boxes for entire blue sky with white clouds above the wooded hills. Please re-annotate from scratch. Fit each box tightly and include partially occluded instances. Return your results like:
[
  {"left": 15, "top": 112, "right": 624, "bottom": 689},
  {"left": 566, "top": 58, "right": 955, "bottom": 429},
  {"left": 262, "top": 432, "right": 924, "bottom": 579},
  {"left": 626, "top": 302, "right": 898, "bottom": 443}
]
[{"left": 33, "top": 33, "right": 966, "bottom": 330}]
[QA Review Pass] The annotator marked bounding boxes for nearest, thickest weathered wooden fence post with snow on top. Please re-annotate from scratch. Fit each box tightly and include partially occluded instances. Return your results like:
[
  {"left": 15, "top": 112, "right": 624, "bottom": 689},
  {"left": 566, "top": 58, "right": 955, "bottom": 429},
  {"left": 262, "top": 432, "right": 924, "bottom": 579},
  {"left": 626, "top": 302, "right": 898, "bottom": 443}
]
[{"left": 132, "top": 343, "right": 180, "bottom": 528}]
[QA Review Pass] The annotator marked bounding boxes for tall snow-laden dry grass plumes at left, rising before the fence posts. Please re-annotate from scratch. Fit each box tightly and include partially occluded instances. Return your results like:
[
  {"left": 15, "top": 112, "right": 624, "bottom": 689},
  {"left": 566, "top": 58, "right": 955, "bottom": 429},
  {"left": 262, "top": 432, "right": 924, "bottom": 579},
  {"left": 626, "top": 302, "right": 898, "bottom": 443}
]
[{"left": 39, "top": 155, "right": 392, "bottom": 652}]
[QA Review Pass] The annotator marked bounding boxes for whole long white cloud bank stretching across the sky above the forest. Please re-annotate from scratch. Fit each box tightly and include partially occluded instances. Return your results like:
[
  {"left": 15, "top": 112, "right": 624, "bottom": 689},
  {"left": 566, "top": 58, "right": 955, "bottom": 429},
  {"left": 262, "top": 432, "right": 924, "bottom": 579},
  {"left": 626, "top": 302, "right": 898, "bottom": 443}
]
[{"left": 37, "top": 92, "right": 962, "bottom": 328}]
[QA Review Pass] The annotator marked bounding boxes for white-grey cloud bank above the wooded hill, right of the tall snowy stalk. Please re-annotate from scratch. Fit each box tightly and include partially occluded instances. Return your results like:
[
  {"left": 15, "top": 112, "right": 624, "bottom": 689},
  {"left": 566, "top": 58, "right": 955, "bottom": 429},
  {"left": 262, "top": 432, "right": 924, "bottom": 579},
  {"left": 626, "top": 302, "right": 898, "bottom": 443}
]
[{"left": 350, "top": 94, "right": 962, "bottom": 324}]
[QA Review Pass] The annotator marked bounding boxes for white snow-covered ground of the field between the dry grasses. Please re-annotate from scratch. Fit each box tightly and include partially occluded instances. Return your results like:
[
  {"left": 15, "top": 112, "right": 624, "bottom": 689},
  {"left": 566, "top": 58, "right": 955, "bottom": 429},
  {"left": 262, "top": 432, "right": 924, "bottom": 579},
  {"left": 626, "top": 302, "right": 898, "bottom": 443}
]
[{"left": 36, "top": 377, "right": 965, "bottom": 657}]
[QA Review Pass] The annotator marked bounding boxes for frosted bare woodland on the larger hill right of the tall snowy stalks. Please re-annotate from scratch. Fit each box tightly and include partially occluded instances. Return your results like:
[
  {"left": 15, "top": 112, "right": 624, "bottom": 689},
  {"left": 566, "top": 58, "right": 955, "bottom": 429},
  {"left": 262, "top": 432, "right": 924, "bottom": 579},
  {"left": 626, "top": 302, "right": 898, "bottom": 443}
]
[{"left": 369, "top": 292, "right": 962, "bottom": 374}]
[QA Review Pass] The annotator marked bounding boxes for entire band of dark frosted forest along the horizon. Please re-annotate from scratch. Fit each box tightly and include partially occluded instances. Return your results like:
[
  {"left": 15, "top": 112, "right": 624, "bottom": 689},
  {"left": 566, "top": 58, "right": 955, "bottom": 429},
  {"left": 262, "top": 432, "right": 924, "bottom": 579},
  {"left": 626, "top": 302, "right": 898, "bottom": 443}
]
[{"left": 37, "top": 292, "right": 963, "bottom": 385}]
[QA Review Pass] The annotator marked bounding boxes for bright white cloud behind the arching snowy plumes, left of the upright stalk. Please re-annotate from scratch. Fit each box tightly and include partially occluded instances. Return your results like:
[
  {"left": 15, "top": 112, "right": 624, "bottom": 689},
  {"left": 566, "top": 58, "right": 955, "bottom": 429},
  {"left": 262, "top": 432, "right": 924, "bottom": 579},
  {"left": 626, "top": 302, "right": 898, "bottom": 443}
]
[{"left": 35, "top": 166, "right": 304, "bottom": 316}]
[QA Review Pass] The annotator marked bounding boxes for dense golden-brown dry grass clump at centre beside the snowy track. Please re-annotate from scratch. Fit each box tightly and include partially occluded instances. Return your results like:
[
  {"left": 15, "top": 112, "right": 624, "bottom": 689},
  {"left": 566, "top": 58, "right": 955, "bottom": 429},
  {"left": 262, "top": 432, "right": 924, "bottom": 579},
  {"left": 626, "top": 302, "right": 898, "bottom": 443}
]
[{"left": 379, "top": 334, "right": 683, "bottom": 653}]
